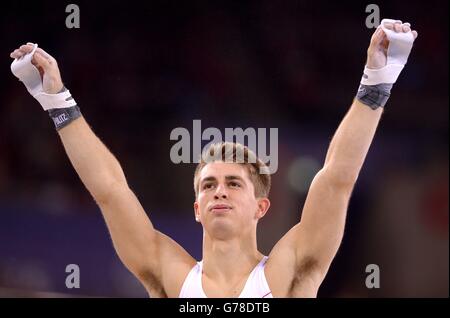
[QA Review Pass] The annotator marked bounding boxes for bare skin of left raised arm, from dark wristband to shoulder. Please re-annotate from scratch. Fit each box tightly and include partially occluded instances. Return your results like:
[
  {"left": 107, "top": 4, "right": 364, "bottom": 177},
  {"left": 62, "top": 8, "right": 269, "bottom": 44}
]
[{"left": 59, "top": 117, "right": 194, "bottom": 296}]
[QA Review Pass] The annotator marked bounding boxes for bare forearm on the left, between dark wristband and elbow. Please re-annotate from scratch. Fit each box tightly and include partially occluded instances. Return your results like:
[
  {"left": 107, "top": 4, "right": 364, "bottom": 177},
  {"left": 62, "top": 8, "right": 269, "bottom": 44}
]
[{"left": 58, "top": 117, "right": 127, "bottom": 202}]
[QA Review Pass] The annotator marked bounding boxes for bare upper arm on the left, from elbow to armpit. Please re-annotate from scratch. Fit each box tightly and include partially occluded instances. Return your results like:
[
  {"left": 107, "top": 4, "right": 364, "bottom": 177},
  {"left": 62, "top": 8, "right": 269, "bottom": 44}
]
[{"left": 98, "top": 184, "right": 195, "bottom": 293}]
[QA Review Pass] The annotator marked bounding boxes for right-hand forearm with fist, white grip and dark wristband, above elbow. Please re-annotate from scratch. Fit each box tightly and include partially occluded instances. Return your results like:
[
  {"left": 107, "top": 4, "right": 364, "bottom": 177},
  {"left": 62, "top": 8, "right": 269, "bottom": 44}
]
[{"left": 325, "top": 19, "right": 417, "bottom": 184}]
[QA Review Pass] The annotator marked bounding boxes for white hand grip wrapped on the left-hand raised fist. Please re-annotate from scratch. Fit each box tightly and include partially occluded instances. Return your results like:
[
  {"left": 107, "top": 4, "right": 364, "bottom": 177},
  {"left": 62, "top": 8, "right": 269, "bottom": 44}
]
[{"left": 11, "top": 44, "right": 77, "bottom": 110}]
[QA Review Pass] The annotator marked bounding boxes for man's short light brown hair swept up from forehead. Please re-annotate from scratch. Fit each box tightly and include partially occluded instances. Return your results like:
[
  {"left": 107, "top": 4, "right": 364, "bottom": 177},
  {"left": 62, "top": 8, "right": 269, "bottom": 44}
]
[{"left": 194, "top": 141, "right": 271, "bottom": 198}]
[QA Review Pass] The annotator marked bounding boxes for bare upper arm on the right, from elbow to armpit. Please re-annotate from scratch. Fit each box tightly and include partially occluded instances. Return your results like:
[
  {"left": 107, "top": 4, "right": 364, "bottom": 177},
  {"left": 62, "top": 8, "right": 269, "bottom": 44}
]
[{"left": 269, "top": 168, "right": 352, "bottom": 296}]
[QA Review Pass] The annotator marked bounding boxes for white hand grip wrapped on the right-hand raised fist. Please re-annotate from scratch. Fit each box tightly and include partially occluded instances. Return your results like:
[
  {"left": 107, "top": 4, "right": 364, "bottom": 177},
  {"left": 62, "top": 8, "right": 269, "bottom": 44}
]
[{"left": 361, "top": 19, "right": 414, "bottom": 85}]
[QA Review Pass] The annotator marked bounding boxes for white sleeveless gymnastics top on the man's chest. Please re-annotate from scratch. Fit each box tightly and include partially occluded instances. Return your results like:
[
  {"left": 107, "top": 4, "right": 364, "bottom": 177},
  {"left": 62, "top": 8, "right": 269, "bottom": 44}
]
[{"left": 179, "top": 256, "right": 272, "bottom": 298}]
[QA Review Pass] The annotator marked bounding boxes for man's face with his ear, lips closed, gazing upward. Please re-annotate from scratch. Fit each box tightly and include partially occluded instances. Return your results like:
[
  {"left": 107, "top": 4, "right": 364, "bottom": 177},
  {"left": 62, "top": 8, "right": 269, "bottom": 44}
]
[{"left": 194, "top": 161, "right": 270, "bottom": 238}]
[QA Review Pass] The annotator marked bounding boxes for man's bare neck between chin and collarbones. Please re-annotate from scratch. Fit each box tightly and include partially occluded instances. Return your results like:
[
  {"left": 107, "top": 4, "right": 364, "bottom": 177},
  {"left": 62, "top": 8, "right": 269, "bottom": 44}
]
[{"left": 203, "top": 231, "right": 263, "bottom": 281}]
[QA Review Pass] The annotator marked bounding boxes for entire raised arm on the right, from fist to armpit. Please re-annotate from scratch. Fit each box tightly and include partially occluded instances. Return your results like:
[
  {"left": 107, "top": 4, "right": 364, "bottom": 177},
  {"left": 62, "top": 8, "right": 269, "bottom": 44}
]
[{"left": 272, "top": 21, "right": 417, "bottom": 297}]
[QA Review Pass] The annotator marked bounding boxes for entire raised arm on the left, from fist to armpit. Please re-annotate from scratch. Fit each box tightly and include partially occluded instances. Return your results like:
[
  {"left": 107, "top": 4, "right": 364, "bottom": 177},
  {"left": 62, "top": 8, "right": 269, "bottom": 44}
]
[{"left": 11, "top": 44, "right": 194, "bottom": 296}]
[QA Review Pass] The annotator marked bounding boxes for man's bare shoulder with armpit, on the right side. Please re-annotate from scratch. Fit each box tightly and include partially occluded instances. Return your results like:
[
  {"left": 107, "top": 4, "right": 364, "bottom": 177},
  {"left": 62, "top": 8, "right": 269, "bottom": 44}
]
[{"left": 264, "top": 225, "right": 320, "bottom": 297}]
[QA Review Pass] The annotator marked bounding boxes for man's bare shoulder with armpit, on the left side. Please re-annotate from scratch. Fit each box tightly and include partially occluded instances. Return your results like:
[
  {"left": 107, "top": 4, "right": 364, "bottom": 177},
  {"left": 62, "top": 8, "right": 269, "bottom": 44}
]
[{"left": 138, "top": 231, "right": 197, "bottom": 298}]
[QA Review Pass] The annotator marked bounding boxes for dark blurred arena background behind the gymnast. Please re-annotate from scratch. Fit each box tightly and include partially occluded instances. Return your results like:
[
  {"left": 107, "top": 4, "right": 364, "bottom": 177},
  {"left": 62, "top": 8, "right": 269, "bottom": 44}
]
[{"left": 0, "top": 0, "right": 449, "bottom": 297}]
